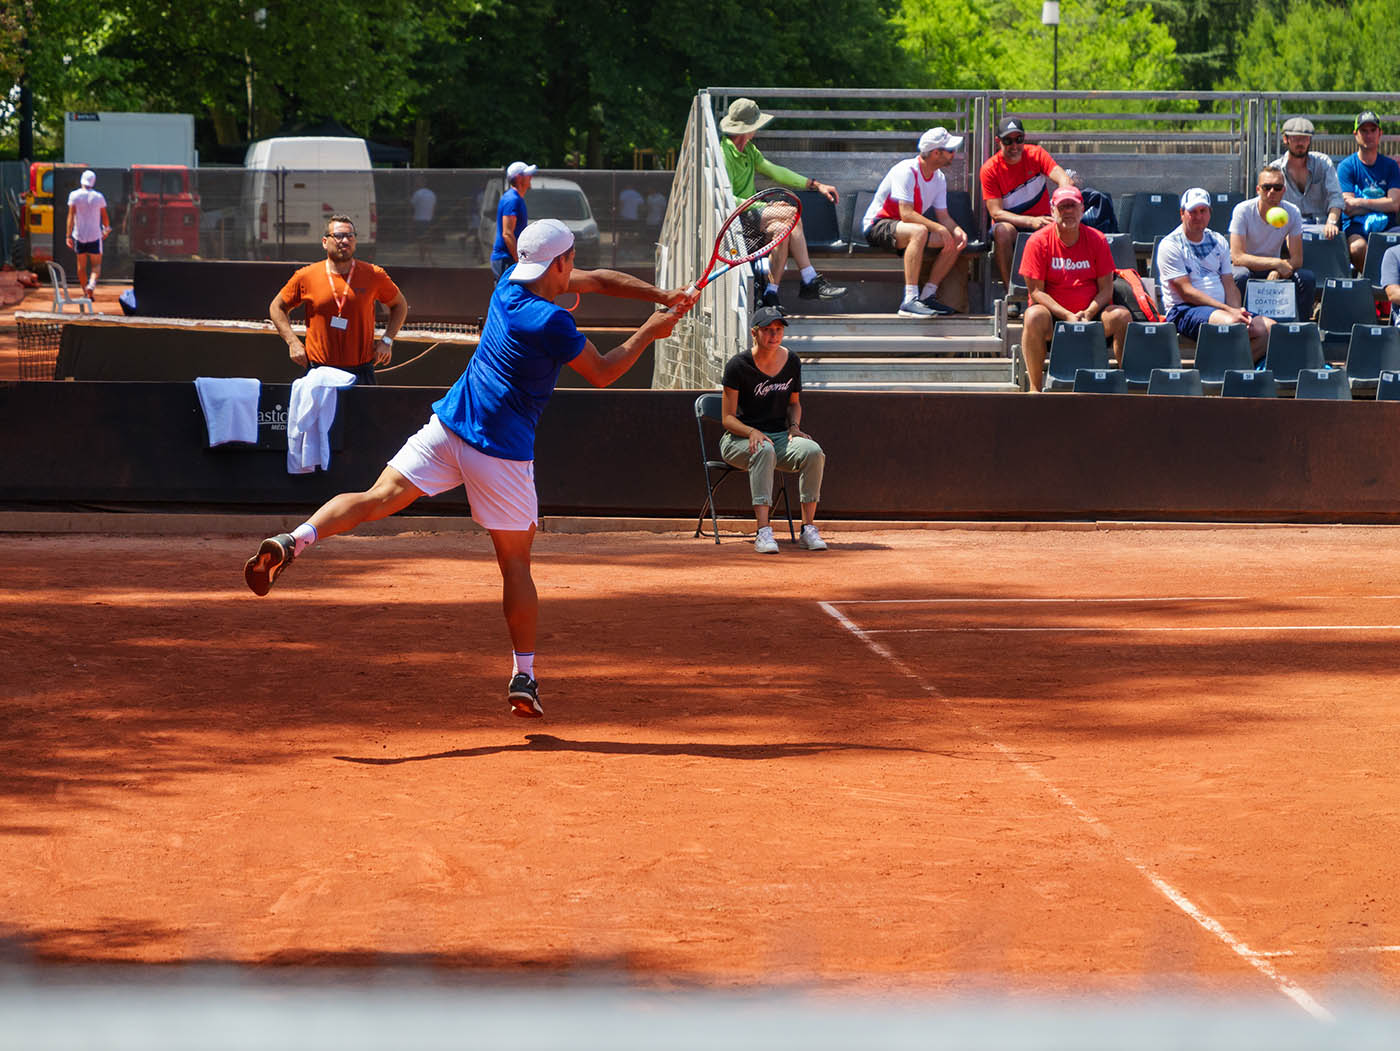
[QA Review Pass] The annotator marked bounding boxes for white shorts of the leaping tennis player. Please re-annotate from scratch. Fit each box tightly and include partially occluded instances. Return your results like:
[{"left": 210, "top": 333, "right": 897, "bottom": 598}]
[{"left": 389, "top": 414, "right": 539, "bottom": 532}]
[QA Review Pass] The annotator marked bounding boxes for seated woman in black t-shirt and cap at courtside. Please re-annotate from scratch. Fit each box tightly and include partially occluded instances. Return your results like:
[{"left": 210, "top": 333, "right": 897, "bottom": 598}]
[{"left": 720, "top": 306, "right": 826, "bottom": 554}]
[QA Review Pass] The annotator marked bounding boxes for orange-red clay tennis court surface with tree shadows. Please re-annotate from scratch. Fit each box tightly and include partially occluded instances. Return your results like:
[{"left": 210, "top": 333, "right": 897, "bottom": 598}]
[{"left": 0, "top": 522, "right": 1400, "bottom": 1024}]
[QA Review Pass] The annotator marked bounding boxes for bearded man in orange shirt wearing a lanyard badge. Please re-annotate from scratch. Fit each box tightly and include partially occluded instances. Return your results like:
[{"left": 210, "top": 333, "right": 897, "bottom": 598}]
[{"left": 267, "top": 216, "right": 409, "bottom": 383}]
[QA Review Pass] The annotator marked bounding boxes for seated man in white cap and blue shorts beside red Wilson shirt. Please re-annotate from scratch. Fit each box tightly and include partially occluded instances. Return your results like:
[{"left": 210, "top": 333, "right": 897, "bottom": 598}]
[{"left": 1155, "top": 186, "right": 1274, "bottom": 361}]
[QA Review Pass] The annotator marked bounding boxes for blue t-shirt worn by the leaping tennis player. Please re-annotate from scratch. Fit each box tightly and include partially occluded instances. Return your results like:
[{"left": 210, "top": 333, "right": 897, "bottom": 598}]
[{"left": 433, "top": 266, "right": 588, "bottom": 460}]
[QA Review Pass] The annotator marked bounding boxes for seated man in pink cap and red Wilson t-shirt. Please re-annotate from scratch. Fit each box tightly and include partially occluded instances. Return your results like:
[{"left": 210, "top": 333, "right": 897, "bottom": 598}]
[{"left": 1021, "top": 186, "right": 1133, "bottom": 393}]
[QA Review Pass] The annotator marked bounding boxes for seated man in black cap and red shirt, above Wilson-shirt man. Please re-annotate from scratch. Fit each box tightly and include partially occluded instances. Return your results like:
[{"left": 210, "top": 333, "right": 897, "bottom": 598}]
[{"left": 980, "top": 116, "right": 1070, "bottom": 303}]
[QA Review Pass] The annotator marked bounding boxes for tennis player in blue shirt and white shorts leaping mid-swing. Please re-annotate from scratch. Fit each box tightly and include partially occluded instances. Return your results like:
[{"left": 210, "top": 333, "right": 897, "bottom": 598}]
[{"left": 244, "top": 218, "right": 694, "bottom": 718}]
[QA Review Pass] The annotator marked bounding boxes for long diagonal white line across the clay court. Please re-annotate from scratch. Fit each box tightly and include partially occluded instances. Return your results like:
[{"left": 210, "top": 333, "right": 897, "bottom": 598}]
[{"left": 818, "top": 602, "right": 1336, "bottom": 1022}]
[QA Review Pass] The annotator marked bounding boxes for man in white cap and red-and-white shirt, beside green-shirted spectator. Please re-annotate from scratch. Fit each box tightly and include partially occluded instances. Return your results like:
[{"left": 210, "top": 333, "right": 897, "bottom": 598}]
[{"left": 861, "top": 127, "right": 967, "bottom": 318}]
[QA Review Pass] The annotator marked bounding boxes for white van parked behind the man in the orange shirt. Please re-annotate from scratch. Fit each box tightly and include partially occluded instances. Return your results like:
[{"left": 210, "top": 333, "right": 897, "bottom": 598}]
[{"left": 244, "top": 136, "right": 379, "bottom": 259}]
